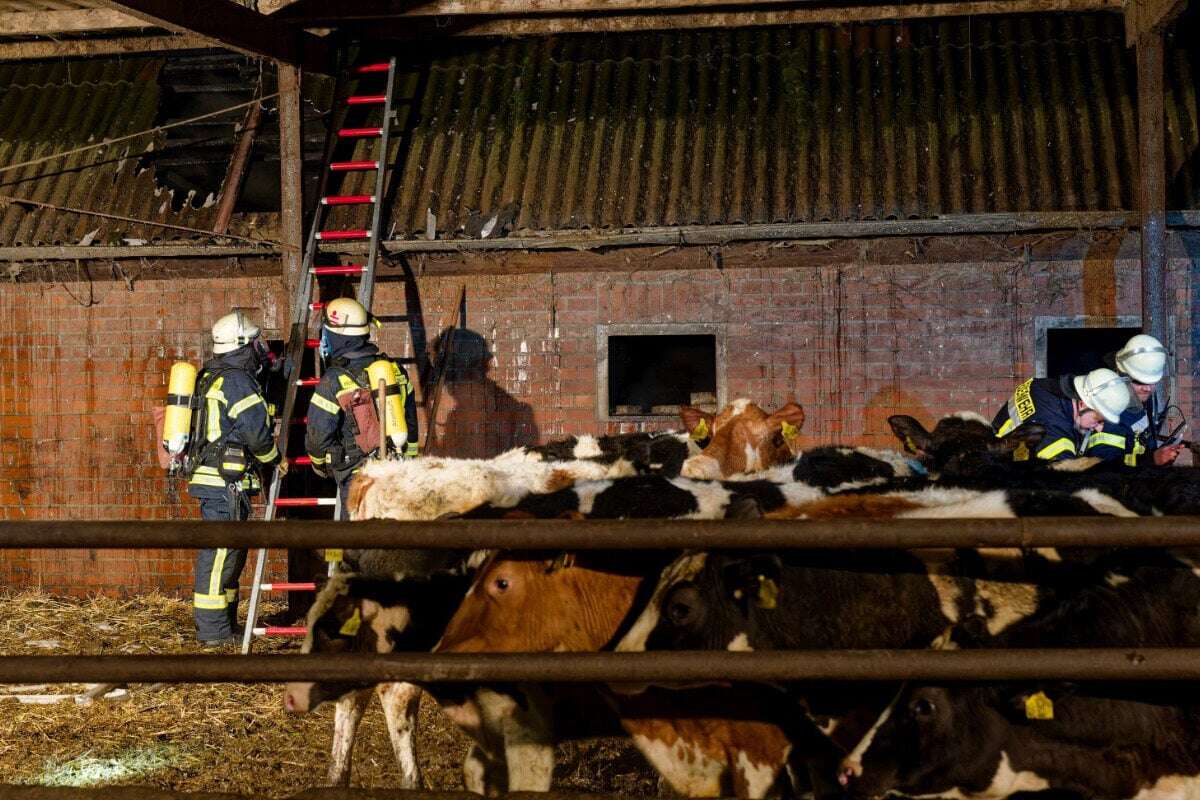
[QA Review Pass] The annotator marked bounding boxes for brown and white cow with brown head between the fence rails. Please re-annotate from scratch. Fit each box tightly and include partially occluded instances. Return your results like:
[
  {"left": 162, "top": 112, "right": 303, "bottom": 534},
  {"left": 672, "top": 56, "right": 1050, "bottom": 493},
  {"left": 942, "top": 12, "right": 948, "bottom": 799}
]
[{"left": 437, "top": 553, "right": 791, "bottom": 798}]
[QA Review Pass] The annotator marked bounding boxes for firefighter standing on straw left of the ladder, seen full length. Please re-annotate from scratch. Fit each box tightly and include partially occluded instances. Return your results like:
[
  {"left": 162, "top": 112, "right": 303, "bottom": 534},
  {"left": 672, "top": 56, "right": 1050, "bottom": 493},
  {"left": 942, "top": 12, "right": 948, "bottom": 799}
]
[{"left": 187, "top": 311, "right": 284, "bottom": 645}]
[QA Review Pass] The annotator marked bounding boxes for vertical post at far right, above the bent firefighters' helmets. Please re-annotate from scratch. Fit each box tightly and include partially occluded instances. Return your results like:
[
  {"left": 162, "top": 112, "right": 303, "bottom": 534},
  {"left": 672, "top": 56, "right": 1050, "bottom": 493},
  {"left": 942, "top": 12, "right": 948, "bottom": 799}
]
[{"left": 1138, "top": 31, "right": 1166, "bottom": 342}]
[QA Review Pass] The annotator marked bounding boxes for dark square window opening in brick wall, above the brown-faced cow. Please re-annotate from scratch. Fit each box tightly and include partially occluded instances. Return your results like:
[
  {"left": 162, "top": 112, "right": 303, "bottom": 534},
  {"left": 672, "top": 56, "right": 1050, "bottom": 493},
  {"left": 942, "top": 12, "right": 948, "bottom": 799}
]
[{"left": 608, "top": 336, "right": 716, "bottom": 416}]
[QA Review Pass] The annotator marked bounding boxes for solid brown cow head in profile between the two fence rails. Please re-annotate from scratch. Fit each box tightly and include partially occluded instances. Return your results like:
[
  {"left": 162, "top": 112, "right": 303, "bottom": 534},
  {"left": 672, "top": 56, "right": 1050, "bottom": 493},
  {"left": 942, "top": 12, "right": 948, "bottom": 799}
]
[{"left": 437, "top": 553, "right": 643, "bottom": 652}]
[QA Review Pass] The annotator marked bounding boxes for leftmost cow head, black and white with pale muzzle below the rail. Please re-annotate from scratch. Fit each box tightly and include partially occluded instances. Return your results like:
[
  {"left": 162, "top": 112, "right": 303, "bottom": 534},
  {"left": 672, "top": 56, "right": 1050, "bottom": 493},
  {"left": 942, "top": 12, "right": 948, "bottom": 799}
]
[{"left": 283, "top": 572, "right": 468, "bottom": 714}]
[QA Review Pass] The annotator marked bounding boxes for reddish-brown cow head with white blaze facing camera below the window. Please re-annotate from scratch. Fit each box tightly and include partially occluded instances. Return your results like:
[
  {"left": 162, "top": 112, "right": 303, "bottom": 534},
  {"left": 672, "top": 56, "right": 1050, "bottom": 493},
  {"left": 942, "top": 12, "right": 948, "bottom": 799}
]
[{"left": 679, "top": 399, "right": 804, "bottom": 480}]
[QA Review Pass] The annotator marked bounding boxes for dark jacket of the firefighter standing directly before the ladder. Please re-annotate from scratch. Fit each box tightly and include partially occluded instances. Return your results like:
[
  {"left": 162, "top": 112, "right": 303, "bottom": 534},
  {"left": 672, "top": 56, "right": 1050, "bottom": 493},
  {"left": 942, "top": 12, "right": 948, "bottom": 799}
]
[{"left": 305, "top": 337, "right": 418, "bottom": 481}]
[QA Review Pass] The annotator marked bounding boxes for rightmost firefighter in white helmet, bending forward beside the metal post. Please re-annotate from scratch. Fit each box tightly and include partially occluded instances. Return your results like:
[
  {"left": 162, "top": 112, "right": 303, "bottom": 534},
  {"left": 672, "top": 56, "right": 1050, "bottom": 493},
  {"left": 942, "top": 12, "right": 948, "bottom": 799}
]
[{"left": 1086, "top": 333, "right": 1183, "bottom": 467}]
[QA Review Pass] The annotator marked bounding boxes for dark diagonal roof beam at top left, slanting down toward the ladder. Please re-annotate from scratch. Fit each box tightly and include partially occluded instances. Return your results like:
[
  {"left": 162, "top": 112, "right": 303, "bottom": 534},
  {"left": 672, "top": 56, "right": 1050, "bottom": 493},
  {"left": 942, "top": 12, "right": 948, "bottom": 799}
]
[{"left": 108, "top": 0, "right": 334, "bottom": 74}]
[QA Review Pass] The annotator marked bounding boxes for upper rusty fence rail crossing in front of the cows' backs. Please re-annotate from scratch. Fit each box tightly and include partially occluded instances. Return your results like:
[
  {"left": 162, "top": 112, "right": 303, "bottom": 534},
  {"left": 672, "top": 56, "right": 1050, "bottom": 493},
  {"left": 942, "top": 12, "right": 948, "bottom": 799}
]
[{"left": 7, "top": 517, "right": 1200, "bottom": 551}]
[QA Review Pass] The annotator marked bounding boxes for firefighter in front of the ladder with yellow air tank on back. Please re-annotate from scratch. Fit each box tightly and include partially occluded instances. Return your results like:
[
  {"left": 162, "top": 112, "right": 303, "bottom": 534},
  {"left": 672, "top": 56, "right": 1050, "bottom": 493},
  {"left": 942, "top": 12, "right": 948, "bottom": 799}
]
[{"left": 305, "top": 297, "right": 418, "bottom": 519}]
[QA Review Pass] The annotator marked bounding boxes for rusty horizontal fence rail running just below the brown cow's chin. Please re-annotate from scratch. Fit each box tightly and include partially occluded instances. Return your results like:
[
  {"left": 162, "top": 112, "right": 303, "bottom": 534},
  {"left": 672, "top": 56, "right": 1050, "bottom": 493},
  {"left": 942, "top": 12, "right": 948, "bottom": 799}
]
[{"left": 0, "top": 648, "right": 1200, "bottom": 685}]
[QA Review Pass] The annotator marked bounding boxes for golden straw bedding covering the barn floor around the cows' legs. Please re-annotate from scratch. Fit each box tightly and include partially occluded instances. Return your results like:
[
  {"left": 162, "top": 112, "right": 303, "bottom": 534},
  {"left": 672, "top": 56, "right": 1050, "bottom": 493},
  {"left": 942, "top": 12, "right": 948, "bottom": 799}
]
[{"left": 0, "top": 593, "right": 656, "bottom": 796}]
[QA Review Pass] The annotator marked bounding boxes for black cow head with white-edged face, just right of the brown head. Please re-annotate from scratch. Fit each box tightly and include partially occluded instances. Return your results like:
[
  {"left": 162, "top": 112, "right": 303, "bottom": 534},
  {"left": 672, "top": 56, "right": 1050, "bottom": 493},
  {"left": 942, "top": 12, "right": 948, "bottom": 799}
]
[{"left": 617, "top": 553, "right": 781, "bottom": 651}]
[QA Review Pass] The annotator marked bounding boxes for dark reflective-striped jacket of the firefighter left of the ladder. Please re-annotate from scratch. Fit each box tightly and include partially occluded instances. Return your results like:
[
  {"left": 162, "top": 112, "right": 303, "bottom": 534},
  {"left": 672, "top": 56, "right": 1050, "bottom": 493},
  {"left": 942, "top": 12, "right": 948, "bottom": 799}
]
[{"left": 187, "top": 347, "right": 280, "bottom": 498}]
